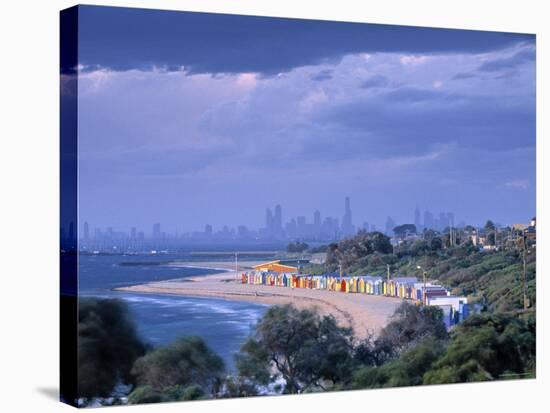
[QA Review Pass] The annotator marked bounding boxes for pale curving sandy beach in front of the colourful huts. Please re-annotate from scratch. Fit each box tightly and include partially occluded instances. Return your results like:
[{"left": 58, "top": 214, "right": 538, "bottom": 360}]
[{"left": 116, "top": 262, "right": 401, "bottom": 338}]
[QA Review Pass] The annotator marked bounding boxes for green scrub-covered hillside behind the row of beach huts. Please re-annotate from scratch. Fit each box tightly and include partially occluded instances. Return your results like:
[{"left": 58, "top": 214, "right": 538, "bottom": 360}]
[{"left": 303, "top": 230, "right": 536, "bottom": 312}]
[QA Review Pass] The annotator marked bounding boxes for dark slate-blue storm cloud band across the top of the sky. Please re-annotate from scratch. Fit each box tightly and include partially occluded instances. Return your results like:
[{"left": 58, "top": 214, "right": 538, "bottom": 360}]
[{"left": 79, "top": 6, "right": 534, "bottom": 75}]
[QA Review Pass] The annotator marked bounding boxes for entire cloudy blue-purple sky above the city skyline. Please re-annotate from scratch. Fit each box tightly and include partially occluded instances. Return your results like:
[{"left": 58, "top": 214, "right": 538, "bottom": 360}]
[{"left": 74, "top": 6, "right": 536, "bottom": 233}]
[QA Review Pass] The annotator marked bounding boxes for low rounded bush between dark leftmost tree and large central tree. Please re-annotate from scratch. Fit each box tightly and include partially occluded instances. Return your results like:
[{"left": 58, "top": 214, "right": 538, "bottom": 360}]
[{"left": 132, "top": 337, "right": 225, "bottom": 400}]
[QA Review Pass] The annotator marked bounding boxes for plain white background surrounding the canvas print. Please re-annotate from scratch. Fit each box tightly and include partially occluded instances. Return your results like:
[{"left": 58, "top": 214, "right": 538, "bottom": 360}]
[{"left": 0, "top": 0, "right": 550, "bottom": 413}]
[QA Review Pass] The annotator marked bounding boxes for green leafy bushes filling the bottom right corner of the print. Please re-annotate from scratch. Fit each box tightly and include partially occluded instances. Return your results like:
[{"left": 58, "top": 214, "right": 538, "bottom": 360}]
[{"left": 353, "top": 314, "right": 536, "bottom": 388}]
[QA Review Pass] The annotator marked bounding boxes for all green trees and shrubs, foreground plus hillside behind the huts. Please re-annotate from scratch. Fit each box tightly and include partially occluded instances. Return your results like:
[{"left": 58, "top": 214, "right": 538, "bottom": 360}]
[{"left": 79, "top": 230, "right": 536, "bottom": 405}]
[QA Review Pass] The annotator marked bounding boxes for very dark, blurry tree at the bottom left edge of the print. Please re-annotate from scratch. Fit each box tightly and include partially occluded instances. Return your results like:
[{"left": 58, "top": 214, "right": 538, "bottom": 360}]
[{"left": 78, "top": 298, "right": 146, "bottom": 398}]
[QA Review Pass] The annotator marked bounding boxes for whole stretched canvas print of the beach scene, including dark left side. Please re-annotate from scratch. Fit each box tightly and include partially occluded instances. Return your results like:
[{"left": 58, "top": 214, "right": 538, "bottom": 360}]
[{"left": 60, "top": 6, "right": 536, "bottom": 407}]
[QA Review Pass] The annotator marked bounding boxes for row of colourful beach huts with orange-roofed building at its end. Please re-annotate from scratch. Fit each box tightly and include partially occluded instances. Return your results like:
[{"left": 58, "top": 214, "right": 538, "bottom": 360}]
[{"left": 241, "top": 261, "right": 469, "bottom": 328}]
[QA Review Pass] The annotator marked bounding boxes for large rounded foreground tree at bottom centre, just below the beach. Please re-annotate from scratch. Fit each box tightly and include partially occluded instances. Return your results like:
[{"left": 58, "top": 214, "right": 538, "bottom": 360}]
[{"left": 237, "top": 305, "right": 353, "bottom": 393}]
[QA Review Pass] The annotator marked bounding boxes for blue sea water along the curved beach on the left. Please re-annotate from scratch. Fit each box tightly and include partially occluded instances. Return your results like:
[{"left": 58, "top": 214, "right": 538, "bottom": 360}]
[{"left": 79, "top": 254, "right": 267, "bottom": 369}]
